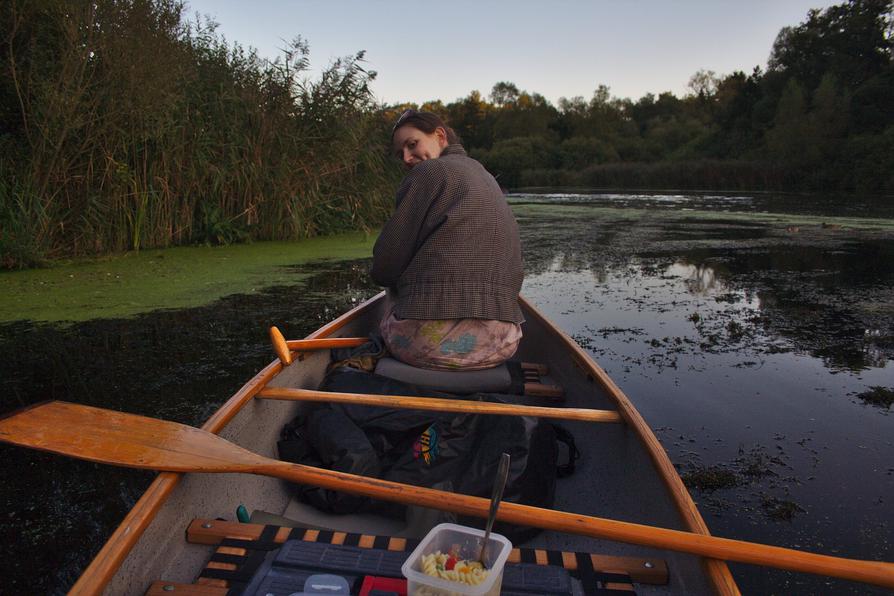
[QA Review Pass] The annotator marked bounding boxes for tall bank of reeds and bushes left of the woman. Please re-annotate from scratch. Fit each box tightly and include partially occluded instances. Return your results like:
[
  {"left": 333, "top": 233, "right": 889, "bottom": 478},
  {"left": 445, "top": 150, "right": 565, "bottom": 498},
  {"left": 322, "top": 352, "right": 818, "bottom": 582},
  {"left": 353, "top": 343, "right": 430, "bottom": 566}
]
[{"left": 0, "top": 0, "right": 394, "bottom": 267}]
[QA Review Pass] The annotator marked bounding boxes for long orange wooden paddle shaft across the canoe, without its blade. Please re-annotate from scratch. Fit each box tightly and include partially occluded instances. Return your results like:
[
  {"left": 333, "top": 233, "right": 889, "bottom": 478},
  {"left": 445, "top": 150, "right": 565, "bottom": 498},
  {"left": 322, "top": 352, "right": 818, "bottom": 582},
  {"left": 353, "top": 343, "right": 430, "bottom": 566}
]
[{"left": 257, "top": 462, "right": 894, "bottom": 588}]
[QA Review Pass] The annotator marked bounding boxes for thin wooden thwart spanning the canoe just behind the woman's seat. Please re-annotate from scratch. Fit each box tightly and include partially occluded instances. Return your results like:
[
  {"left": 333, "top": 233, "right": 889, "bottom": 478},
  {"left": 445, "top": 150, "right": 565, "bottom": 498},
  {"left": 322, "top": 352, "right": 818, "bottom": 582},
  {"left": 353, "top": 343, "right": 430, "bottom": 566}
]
[{"left": 257, "top": 387, "right": 621, "bottom": 422}]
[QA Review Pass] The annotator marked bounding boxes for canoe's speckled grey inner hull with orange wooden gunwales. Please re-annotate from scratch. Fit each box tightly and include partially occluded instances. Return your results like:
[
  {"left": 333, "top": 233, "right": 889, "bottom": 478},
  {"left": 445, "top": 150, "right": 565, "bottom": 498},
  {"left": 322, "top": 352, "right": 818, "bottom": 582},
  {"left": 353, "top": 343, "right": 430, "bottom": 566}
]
[{"left": 57, "top": 294, "right": 738, "bottom": 594}]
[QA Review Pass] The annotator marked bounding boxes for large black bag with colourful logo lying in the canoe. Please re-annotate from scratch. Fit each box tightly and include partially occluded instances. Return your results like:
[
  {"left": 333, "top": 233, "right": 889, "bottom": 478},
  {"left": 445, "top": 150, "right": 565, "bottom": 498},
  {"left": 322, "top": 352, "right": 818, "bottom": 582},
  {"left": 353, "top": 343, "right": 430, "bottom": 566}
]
[{"left": 279, "top": 368, "right": 579, "bottom": 542}]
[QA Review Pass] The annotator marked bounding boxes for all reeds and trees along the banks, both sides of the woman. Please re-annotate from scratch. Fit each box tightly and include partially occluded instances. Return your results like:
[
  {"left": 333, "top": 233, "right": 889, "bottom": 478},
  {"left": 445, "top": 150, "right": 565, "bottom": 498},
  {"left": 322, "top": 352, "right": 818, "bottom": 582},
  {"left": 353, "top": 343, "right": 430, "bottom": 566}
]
[{"left": 0, "top": 0, "right": 894, "bottom": 269}]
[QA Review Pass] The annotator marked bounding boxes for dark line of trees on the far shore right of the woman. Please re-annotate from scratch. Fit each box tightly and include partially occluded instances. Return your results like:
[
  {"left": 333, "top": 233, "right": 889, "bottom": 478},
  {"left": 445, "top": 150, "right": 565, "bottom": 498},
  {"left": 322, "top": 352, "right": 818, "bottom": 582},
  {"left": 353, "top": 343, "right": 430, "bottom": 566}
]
[{"left": 401, "top": 0, "right": 894, "bottom": 192}]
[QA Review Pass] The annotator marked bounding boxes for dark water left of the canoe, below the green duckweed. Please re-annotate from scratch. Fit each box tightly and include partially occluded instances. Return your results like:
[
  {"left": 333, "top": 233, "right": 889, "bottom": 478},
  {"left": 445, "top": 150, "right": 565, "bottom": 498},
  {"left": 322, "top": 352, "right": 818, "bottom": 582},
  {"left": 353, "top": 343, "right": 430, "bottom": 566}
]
[{"left": 0, "top": 263, "right": 378, "bottom": 594}]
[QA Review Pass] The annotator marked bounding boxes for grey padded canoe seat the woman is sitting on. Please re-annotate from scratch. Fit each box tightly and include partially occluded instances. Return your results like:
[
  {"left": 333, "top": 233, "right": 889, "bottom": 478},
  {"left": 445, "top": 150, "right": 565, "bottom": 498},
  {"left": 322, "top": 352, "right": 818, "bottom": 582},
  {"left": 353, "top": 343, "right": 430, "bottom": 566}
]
[{"left": 375, "top": 358, "right": 564, "bottom": 399}]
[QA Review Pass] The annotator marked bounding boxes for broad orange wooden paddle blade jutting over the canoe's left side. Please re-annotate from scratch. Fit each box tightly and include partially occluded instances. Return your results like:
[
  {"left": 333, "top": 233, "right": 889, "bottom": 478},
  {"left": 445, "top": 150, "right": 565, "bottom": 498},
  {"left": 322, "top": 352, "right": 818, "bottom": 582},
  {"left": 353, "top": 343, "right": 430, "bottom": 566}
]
[{"left": 0, "top": 401, "right": 266, "bottom": 472}]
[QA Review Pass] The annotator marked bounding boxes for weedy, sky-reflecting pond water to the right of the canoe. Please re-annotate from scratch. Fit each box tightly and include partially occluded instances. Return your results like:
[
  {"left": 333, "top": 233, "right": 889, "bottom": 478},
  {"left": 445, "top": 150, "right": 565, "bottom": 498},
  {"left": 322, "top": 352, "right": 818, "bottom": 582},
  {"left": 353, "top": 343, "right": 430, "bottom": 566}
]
[{"left": 513, "top": 195, "right": 894, "bottom": 594}]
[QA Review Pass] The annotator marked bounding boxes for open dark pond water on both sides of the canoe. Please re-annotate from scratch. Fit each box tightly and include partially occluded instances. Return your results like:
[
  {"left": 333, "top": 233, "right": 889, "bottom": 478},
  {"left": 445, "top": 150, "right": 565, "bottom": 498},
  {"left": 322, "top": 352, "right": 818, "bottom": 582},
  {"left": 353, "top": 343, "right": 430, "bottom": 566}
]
[{"left": 0, "top": 193, "right": 894, "bottom": 594}]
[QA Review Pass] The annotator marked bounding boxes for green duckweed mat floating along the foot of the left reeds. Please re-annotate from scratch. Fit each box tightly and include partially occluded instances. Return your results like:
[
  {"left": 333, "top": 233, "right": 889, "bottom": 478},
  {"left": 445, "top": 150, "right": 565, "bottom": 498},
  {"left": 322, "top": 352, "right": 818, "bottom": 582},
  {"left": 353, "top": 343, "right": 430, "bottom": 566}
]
[{"left": 0, "top": 233, "right": 375, "bottom": 322}]
